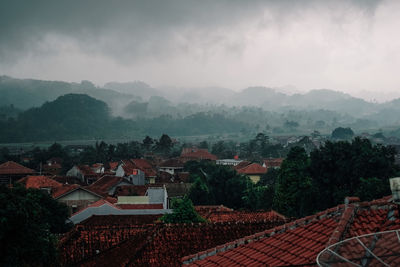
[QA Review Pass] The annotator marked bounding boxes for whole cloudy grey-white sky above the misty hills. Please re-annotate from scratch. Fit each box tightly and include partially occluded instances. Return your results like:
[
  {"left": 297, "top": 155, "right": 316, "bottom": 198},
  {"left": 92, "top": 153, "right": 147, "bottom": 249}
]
[{"left": 0, "top": 0, "right": 400, "bottom": 101}]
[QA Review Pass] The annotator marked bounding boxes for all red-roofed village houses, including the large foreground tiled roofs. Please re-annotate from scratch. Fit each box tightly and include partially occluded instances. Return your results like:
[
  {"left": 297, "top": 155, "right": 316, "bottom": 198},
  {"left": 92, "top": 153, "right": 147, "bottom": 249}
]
[{"left": 0, "top": 144, "right": 400, "bottom": 266}]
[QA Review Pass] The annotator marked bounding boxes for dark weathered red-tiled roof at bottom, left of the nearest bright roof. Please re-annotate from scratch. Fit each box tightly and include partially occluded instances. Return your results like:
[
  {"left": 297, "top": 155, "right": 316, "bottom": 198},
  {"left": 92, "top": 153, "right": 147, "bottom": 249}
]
[{"left": 60, "top": 216, "right": 284, "bottom": 266}]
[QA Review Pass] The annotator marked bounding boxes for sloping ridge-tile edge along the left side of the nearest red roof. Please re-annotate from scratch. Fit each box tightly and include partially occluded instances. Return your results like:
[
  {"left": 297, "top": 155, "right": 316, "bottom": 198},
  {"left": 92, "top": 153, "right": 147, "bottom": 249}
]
[{"left": 181, "top": 204, "right": 345, "bottom": 265}]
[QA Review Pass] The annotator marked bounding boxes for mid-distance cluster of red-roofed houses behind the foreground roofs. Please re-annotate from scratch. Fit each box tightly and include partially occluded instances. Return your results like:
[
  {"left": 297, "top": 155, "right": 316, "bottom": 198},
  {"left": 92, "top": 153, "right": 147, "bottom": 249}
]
[{"left": 0, "top": 147, "right": 283, "bottom": 224}]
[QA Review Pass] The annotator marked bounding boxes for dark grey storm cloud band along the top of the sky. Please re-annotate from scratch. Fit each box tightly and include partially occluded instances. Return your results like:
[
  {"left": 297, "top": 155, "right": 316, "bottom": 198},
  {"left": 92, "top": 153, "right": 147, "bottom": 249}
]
[{"left": 0, "top": 0, "right": 379, "bottom": 60}]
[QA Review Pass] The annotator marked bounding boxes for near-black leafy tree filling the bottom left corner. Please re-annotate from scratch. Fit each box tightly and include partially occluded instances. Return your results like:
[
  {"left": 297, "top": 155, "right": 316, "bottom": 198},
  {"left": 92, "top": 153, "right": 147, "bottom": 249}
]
[{"left": 0, "top": 185, "right": 69, "bottom": 266}]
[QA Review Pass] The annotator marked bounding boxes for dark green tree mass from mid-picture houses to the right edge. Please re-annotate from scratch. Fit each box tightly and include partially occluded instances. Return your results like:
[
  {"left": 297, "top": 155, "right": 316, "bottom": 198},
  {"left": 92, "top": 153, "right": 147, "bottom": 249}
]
[{"left": 186, "top": 138, "right": 399, "bottom": 217}]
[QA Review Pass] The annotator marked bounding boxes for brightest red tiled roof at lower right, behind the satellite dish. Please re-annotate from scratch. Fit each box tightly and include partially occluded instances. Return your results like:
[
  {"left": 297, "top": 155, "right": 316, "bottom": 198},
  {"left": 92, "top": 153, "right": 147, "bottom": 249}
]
[{"left": 182, "top": 198, "right": 400, "bottom": 266}]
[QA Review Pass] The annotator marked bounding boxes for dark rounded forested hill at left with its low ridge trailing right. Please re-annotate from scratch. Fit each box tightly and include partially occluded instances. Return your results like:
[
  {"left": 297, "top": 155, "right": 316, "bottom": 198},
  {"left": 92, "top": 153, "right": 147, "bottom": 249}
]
[{"left": 0, "top": 94, "right": 247, "bottom": 143}]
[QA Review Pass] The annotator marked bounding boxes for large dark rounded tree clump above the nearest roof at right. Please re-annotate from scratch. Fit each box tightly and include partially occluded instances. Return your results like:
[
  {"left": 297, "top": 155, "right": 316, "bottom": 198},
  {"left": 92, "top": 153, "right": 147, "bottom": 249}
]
[{"left": 273, "top": 138, "right": 399, "bottom": 217}]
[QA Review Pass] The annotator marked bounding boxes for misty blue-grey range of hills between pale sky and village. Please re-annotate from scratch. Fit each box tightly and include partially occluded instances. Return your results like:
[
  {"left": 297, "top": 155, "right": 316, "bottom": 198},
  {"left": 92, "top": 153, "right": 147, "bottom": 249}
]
[{"left": 0, "top": 76, "right": 400, "bottom": 141}]
